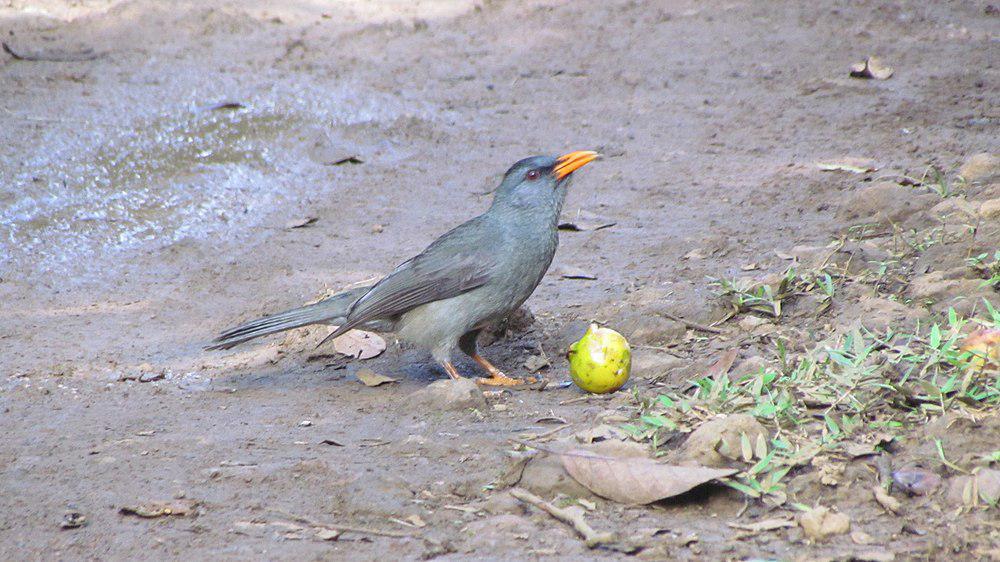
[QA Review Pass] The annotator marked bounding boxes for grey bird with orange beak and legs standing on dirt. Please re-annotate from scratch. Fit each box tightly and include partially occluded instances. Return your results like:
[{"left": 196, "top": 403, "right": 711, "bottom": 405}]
[{"left": 206, "top": 150, "right": 600, "bottom": 386}]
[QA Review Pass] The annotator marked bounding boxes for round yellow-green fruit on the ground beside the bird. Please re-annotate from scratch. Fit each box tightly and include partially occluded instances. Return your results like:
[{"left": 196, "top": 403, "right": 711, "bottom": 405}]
[{"left": 569, "top": 324, "right": 632, "bottom": 394}]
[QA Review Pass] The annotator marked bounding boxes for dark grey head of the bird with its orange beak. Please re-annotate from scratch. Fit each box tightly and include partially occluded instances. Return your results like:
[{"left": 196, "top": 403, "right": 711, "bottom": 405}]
[{"left": 493, "top": 150, "right": 599, "bottom": 210}]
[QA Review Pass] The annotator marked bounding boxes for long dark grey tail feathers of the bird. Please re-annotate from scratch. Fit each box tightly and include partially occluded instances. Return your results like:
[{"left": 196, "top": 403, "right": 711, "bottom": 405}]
[{"left": 205, "top": 287, "right": 371, "bottom": 349}]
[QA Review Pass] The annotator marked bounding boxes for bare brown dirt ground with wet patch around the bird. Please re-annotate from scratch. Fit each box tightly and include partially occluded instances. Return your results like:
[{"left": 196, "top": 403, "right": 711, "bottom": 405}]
[{"left": 0, "top": 0, "right": 1000, "bottom": 560}]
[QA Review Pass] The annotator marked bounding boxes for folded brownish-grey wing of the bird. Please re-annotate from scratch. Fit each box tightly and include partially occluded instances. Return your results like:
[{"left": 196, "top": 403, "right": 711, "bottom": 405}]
[{"left": 324, "top": 217, "right": 503, "bottom": 341}]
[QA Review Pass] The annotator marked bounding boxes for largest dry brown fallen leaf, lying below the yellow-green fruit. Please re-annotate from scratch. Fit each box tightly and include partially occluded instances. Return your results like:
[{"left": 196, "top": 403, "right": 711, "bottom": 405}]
[{"left": 560, "top": 449, "right": 737, "bottom": 504}]
